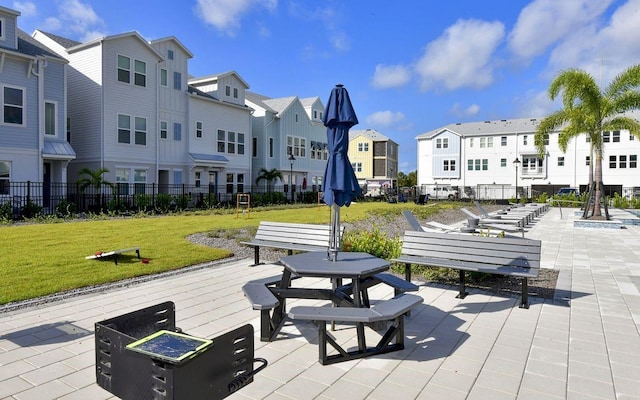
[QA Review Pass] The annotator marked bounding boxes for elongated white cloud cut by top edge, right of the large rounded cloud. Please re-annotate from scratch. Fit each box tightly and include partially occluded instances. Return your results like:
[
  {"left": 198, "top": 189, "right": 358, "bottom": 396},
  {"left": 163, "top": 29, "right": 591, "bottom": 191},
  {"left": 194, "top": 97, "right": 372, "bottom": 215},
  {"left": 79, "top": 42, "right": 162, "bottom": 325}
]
[{"left": 508, "top": 0, "right": 613, "bottom": 60}]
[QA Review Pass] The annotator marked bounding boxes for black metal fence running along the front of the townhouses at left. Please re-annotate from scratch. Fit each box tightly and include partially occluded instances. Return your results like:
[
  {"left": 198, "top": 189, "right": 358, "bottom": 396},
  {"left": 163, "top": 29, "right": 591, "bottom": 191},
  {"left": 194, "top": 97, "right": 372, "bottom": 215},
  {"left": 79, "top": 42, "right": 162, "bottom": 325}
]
[{"left": 0, "top": 181, "right": 328, "bottom": 219}]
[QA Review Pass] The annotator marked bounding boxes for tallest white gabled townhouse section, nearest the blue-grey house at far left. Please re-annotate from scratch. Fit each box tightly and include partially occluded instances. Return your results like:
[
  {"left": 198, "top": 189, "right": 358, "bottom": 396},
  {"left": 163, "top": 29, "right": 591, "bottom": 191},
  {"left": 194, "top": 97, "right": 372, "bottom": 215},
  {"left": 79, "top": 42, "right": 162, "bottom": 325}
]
[{"left": 33, "top": 30, "right": 164, "bottom": 194}]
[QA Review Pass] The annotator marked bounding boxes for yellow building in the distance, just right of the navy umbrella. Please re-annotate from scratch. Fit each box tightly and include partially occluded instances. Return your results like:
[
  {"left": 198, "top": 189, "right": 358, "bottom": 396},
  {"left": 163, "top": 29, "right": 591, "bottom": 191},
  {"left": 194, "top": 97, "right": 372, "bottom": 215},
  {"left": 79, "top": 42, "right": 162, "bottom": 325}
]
[{"left": 349, "top": 129, "right": 398, "bottom": 196}]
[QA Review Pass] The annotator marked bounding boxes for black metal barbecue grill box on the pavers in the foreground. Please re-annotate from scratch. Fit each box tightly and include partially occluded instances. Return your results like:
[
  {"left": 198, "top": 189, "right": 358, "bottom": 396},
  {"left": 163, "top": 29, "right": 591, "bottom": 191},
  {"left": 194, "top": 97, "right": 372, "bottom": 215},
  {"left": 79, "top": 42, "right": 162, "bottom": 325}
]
[{"left": 95, "top": 302, "right": 266, "bottom": 400}]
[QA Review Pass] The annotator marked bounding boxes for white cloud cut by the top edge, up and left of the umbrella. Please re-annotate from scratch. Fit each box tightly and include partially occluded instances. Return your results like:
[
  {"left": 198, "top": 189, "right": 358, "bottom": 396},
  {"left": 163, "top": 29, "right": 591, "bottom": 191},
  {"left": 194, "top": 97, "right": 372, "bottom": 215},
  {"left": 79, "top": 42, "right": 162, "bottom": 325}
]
[{"left": 196, "top": 0, "right": 278, "bottom": 36}]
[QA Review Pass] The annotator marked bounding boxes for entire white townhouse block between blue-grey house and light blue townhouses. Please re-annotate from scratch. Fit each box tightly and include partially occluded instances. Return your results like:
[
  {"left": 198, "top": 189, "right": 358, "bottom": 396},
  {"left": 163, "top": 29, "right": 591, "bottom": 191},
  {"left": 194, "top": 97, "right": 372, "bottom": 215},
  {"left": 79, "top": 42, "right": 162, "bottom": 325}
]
[{"left": 34, "top": 31, "right": 251, "bottom": 200}]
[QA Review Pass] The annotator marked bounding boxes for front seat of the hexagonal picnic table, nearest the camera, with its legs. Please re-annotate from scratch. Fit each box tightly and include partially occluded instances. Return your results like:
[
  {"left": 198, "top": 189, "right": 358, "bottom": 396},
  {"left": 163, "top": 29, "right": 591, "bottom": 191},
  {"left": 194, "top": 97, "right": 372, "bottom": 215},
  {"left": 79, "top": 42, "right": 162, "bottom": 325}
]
[{"left": 288, "top": 294, "right": 423, "bottom": 365}]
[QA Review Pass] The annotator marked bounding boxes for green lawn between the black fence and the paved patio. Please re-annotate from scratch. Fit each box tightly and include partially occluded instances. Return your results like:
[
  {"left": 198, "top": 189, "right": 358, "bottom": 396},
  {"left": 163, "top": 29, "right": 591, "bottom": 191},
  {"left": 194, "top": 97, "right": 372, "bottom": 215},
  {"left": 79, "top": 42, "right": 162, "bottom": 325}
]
[{"left": 0, "top": 202, "right": 440, "bottom": 304}]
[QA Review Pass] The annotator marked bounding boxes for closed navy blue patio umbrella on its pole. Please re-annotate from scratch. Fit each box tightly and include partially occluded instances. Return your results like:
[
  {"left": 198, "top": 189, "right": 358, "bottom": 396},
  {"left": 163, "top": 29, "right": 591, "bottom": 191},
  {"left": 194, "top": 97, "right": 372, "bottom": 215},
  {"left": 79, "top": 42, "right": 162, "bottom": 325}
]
[{"left": 322, "top": 85, "right": 361, "bottom": 261}]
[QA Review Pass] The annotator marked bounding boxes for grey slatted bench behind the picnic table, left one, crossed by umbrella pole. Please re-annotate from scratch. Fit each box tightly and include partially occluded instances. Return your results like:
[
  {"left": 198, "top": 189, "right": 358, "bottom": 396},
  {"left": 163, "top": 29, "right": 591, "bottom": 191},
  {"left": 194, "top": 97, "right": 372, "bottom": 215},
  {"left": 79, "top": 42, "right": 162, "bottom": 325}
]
[{"left": 241, "top": 221, "right": 344, "bottom": 265}]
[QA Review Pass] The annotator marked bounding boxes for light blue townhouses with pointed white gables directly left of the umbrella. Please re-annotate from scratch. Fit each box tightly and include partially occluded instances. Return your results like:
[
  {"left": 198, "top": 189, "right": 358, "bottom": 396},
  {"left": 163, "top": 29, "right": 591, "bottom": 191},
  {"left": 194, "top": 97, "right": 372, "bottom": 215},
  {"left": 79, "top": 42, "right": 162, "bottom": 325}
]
[{"left": 246, "top": 92, "right": 329, "bottom": 192}]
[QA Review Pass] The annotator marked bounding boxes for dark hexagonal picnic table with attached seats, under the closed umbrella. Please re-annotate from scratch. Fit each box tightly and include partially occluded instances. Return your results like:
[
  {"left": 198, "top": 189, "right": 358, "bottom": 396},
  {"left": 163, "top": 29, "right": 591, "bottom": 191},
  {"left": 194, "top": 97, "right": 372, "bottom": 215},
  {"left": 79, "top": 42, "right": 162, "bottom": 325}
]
[{"left": 243, "top": 251, "right": 422, "bottom": 364}]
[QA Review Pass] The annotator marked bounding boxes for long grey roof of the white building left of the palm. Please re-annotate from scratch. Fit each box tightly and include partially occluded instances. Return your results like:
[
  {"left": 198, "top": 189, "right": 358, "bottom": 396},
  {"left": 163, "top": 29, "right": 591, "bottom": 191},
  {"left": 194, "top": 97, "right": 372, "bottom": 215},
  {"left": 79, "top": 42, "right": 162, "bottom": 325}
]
[{"left": 416, "top": 118, "right": 540, "bottom": 139}]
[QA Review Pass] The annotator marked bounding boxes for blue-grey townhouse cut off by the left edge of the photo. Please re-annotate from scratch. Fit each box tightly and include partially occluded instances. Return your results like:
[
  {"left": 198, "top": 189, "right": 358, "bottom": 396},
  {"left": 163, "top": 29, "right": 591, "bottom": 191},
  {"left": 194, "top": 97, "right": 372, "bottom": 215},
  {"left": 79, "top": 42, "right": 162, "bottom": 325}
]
[{"left": 0, "top": 6, "right": 76, "bottom": 208}]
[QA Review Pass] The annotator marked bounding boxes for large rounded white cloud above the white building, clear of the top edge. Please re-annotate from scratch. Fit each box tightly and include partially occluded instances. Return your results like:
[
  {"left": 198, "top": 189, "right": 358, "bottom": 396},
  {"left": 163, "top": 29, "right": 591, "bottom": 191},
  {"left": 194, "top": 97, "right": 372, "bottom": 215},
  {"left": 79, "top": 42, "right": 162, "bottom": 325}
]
[{"left": 415, "top": 20, "right": 505, "bottom": 90}]
